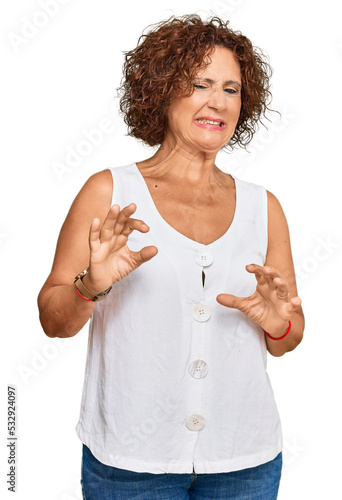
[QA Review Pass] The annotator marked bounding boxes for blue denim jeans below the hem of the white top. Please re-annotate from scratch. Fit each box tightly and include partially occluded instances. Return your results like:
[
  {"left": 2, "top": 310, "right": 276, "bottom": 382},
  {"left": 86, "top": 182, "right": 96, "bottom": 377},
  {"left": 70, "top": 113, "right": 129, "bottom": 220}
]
[{"left": 81, "top": 445, "right": 282, "bottom": 500}]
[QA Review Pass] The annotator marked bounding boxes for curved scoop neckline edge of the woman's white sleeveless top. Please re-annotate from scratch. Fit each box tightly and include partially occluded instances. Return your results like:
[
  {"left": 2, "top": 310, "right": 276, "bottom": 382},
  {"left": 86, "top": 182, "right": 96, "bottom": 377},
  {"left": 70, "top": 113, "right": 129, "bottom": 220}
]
[{"left": 132, "top": 163, "right": 240, "bottom": 248}]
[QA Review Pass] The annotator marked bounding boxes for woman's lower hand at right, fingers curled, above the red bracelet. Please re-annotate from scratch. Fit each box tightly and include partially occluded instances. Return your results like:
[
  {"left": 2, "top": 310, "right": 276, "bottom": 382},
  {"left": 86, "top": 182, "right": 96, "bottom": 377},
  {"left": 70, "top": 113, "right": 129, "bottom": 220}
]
[{"left": 217, "top": 264, "right": 302, "bottom": 337}]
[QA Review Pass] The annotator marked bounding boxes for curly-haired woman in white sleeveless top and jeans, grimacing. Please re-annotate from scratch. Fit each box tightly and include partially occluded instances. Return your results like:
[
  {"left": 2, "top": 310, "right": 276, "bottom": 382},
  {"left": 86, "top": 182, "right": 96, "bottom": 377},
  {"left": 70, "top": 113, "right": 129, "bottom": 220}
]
[{"left": 39, "top": 16, "right": 304, "bottom": 500}]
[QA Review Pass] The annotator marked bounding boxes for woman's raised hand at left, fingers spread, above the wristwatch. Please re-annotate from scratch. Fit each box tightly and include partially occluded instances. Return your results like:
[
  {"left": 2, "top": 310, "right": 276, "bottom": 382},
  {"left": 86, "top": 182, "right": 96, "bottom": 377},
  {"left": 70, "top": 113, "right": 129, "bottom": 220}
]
[{"left": 82, "top": 203, "right": 158, "bottom": 294}]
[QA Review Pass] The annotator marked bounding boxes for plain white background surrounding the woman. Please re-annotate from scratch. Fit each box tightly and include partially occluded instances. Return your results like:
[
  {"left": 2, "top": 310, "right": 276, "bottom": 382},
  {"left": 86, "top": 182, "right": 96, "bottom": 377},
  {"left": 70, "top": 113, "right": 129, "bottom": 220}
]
[{"left": 0, "top": 0, "right": 342, "bottom": 500}]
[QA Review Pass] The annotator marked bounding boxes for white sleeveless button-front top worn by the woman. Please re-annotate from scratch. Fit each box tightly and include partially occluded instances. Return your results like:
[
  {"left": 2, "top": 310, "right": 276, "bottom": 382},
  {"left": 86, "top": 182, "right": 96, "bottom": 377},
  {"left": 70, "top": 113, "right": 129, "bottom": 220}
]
[{"left": 76, "top": 164, "right": 282, "bottom": 473}]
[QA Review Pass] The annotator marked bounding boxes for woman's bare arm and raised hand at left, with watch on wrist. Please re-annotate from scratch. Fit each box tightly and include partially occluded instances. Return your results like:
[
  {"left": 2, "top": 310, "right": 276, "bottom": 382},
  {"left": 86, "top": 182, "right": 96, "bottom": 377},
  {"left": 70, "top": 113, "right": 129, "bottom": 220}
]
[{"left": 38, "top": 170, "right": 157, "bottom": 337}]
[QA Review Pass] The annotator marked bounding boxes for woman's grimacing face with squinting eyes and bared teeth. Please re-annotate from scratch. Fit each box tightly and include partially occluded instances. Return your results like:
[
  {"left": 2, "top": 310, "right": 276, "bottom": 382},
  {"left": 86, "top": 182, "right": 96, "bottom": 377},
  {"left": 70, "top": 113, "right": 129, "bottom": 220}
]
[{"left": 166, "top": 47, "right": 241, "bottom": 154}]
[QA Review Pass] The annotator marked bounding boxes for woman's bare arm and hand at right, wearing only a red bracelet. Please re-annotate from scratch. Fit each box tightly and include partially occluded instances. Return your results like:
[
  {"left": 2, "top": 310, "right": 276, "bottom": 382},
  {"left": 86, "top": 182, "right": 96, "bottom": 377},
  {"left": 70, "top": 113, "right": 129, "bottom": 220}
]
[{"left": 217, "top": 192, "right": 304, "bottom": 356}]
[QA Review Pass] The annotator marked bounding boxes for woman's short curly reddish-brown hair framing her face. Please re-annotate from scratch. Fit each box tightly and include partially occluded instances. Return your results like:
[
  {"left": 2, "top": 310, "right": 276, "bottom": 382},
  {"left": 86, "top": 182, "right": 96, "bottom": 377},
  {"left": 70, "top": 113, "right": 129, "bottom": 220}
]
[{"left": 118, "top": 14, "right": 272, "bottom": 147}]
